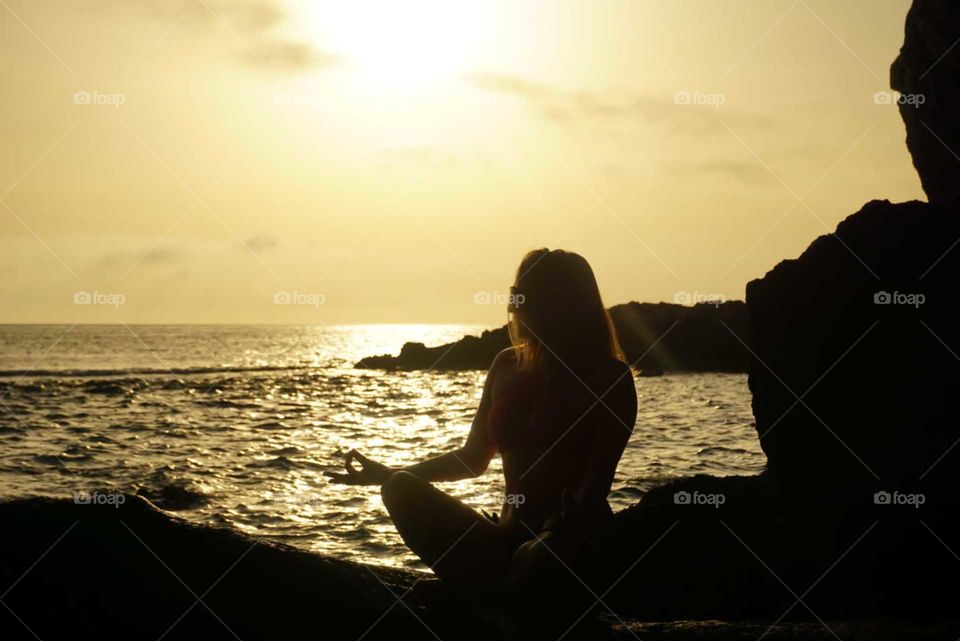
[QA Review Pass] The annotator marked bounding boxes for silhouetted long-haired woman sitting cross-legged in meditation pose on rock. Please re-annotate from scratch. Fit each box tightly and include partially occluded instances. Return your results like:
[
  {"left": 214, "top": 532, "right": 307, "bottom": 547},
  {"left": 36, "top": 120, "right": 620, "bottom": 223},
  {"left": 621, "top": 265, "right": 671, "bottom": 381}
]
[{"left": 330, "top": 249, "right": 637, "bottom": 587}]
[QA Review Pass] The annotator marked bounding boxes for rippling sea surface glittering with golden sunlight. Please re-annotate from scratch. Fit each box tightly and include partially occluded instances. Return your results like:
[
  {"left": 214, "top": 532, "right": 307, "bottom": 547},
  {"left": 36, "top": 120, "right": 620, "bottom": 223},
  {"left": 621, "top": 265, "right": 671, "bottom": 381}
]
[{"left": 0, "top": 325, "right": 766, "bottom": 568}]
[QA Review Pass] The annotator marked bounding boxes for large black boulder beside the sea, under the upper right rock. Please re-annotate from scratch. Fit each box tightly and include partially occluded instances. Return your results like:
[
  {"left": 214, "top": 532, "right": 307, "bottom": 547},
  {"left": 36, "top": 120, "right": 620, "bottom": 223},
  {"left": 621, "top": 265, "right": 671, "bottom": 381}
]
[{"left": 747, "top": 201, "right": 960, "bottom": 502}]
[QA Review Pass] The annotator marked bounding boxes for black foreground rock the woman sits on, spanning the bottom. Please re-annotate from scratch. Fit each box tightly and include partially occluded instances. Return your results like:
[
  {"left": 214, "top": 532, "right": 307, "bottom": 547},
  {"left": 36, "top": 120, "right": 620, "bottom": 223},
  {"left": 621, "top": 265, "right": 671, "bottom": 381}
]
[{"left": 0, "top": 484, "right": 960, "bottom": 641}]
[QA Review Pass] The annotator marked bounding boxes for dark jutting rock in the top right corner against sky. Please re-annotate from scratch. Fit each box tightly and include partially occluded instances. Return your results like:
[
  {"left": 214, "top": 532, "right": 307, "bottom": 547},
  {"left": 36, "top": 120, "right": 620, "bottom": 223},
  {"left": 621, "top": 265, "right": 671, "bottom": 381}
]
[{"left": 890, "top": 0, "right": 960, "bottom": 202}]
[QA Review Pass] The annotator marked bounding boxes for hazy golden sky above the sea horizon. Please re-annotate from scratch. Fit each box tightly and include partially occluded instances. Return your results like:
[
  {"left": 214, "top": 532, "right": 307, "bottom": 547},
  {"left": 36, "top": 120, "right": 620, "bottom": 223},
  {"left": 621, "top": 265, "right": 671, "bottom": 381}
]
[{"left": 0, "top": 0, "right": 923, "bottom": 326}]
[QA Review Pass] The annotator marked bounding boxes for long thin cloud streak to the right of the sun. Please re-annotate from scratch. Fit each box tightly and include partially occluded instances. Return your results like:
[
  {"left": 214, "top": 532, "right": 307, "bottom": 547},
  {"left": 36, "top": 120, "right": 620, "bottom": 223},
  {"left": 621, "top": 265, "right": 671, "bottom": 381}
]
[{"left": 465, "top": 73, "right": 773, "bottom": 133}]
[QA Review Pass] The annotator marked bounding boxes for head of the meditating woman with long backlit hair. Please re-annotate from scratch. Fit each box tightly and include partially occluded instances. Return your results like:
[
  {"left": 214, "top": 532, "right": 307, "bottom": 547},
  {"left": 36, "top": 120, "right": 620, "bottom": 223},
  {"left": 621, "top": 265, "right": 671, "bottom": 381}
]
[{"left": 509, "top": 249, "right": 623, "bottom": 367}]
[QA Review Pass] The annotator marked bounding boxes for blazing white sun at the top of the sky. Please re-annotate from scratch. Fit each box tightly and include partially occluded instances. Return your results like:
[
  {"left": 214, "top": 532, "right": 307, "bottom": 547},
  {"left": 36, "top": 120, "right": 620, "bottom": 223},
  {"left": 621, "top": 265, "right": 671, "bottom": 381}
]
[{"left": 302, "top": 0, "right": 487, "bottom": 87}]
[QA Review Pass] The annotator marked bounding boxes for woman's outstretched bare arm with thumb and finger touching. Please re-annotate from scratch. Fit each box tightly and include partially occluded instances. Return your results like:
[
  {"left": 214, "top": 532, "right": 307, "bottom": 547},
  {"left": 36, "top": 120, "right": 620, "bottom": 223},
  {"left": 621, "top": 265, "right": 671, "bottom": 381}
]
[{"left": 327, "top": 349, "right": 514, "bottom": 485}]
